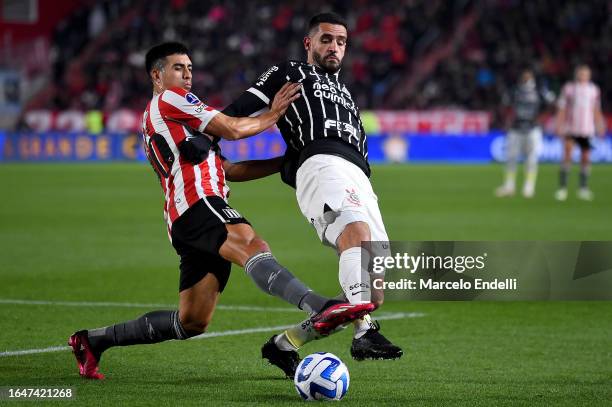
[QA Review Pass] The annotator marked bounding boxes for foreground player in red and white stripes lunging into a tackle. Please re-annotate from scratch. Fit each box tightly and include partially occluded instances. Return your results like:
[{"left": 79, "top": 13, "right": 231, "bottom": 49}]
[{"left": 68, "top": 42, "right": 374, "bottom": 379}]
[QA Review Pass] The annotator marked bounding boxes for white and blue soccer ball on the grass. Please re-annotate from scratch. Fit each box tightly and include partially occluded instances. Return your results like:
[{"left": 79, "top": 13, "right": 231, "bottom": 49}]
[{"left": 293, "top": 352, "right": 350, "bottom": 401}]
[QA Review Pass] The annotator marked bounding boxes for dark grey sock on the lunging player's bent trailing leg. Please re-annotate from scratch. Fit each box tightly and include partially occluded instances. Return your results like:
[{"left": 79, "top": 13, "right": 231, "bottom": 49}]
[{"left": 87, "top": 311, "right": 189, "bottom": 354}]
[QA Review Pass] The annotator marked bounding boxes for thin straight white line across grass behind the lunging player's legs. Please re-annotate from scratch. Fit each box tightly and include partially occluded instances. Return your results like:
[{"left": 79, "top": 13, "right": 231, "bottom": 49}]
[{"left": 0, "top": 298, "right": 304, "bottom": 312}]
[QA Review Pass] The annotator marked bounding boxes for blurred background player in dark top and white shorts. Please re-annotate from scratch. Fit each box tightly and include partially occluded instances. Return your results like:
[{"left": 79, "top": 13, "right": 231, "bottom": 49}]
[{"left": 495, "top": 69, "right": 554, "bottom": 198}]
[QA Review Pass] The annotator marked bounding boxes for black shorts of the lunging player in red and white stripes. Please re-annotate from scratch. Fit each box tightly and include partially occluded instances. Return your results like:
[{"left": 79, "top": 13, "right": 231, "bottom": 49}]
[{"left": 170, "top": 196, "right": 249, "bottom": 292}]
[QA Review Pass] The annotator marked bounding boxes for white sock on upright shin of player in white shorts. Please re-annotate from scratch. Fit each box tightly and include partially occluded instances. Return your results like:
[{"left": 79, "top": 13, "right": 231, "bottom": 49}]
[{"left": 338, "top": 247, "right": 371, "bottom": 304}]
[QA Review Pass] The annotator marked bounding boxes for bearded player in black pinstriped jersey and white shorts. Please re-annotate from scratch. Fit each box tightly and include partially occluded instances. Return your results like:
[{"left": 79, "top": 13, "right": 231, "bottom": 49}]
[{"left": 223, "top": 13, "right": 402, "bottom": 377}]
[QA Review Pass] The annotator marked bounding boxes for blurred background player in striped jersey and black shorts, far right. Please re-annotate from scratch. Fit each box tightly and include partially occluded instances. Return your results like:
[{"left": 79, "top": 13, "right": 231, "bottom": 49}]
[{"left": 555, "top": 65, "right": 605, "bottom": 201}]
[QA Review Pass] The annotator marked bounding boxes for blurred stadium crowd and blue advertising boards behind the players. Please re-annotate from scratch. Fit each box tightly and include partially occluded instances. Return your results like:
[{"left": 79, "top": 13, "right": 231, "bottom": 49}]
[{"left": 0, "top": 0, "right": 612, "bottom": 163}]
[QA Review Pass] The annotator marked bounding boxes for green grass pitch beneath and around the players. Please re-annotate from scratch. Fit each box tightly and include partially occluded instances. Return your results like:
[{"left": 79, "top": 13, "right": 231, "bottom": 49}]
[{"left": 0, "top": 164, "right": 612, "bottom": 406}]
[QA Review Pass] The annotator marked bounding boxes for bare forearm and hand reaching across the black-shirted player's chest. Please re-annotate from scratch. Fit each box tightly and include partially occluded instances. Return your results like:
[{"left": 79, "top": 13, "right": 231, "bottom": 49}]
[{"left": 204, "top": 82, "right": 301, "bottom": 140}]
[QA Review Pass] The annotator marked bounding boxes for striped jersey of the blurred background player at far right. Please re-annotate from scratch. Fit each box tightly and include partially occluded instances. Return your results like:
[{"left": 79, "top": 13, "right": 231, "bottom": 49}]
[{"left": 558, "top": 82, "right": 601, "bottom": 137}]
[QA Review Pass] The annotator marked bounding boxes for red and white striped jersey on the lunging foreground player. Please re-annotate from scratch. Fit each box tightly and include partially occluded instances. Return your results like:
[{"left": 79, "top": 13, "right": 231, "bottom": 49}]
[{"left": 142, "top": 88, "right": 229, "bottom": 231}]
